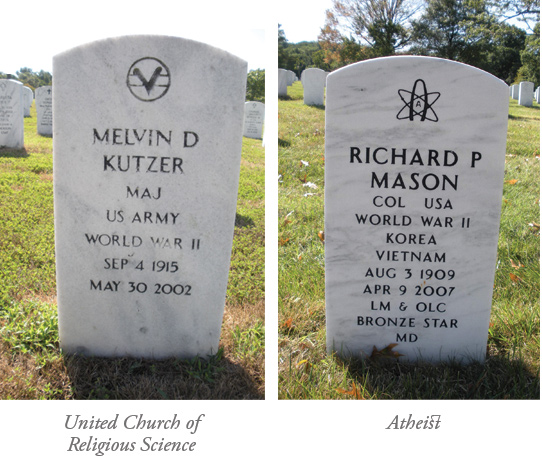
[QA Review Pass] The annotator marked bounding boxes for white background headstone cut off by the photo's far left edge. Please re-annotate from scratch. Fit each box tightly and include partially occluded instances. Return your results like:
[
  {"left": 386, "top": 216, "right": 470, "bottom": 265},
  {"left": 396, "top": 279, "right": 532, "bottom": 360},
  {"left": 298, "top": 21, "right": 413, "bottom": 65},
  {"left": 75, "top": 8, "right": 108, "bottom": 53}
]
[{"left": 0, "top": 79, "right": 24, "bottom": 149}]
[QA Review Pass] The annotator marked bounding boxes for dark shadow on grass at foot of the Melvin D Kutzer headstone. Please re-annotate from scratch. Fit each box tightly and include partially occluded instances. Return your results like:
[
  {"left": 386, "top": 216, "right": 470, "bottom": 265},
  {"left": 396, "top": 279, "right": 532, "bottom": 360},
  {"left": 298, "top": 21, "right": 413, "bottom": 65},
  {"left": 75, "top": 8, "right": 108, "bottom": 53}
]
[{"left": 64, "top": 351, "right": 264, "bottom": 400}]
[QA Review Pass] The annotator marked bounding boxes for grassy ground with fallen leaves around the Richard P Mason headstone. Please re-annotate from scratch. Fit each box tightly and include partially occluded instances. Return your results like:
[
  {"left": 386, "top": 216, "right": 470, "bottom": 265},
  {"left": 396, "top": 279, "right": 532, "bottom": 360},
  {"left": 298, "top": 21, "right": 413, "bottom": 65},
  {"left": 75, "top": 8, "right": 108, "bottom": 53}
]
[{"left": 278, "top": 82, "right": 540, "bottom": 399}]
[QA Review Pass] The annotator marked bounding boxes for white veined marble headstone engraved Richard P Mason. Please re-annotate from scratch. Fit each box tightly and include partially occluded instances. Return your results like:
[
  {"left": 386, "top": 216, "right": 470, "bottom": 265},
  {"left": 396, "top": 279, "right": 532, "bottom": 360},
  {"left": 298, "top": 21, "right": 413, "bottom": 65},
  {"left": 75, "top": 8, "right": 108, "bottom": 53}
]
[{"left": 325, "top": 56, "right": 509, "bottom": 362}]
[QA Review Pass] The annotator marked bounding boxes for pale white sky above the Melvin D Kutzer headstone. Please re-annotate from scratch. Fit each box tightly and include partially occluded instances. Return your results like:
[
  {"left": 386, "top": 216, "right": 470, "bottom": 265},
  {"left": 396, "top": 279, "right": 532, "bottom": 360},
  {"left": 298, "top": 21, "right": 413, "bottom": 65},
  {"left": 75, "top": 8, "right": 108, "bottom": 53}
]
[{"left": 0, "top": 0, "right": 268, "bottom": 74}]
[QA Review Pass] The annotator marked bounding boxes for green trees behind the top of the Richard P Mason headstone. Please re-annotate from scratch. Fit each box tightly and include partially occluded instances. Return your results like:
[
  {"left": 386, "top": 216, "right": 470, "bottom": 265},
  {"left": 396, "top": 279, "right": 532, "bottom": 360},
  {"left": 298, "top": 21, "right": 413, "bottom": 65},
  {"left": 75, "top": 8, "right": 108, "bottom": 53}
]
[{"left": 278, "top": 0, "right": 540, "bottom": 86}]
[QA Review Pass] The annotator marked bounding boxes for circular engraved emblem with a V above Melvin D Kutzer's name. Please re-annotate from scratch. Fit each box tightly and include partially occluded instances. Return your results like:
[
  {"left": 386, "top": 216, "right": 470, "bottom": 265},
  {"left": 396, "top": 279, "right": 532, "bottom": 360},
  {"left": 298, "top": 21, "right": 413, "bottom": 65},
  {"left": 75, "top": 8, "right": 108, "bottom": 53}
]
[{"left": 126, "top": 57, "right": 171, "bottom": 102}]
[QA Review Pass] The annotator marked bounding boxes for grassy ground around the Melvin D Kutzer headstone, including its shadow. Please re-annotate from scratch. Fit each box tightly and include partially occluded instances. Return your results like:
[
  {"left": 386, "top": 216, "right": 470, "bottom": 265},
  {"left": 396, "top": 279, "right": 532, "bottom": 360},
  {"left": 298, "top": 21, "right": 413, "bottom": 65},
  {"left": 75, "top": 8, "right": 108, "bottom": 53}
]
[{"left": 0, "top": 106, "right": 265, "bottom": 400}]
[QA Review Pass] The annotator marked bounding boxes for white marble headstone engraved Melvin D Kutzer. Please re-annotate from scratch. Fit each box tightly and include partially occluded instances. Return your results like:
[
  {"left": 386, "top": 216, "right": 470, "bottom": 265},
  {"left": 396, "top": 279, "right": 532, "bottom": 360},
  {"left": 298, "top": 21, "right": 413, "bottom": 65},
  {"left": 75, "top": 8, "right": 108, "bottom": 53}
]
[{"left": 53, "top": 36, "right": 247, "bottom": 358}]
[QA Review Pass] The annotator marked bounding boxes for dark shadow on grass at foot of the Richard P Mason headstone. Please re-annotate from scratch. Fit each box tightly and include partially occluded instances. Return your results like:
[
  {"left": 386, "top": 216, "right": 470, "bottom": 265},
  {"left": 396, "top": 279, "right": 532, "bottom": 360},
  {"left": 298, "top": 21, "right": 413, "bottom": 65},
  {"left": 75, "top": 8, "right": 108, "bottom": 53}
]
[{"left": 338, "top": 355, "right": 540, "bottom": 400}]
